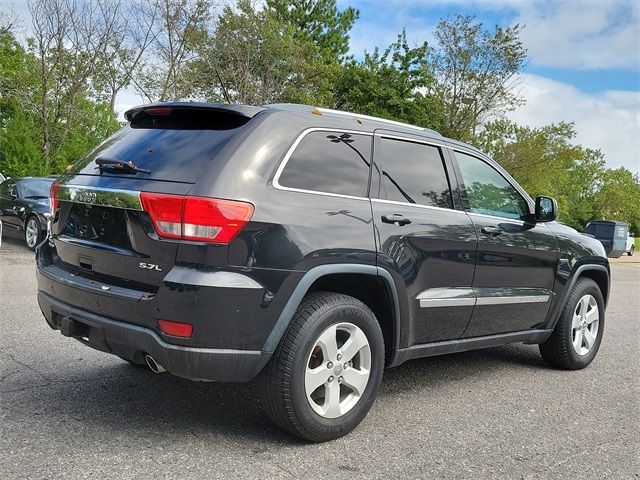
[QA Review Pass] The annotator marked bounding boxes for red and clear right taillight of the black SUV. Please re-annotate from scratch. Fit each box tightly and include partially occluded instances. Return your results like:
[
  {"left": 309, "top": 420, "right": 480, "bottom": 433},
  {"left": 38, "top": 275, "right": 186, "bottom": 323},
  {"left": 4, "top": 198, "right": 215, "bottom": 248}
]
[{"left": 140, "top": 192, "right": 253, "bottom": 244}]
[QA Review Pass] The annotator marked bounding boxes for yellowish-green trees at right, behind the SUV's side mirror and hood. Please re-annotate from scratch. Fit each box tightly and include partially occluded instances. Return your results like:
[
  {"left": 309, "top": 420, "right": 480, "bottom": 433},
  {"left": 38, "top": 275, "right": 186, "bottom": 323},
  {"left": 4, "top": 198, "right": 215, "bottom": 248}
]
[{"left": 474, "top": 120, "right": 640, "bottom": 231}]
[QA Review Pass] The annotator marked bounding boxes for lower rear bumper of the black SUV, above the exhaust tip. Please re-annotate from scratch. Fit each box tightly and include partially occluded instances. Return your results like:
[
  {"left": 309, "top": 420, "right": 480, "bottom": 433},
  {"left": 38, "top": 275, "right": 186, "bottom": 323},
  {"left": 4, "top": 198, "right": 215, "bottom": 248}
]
[{"left": 38, "top": 291, "right": 271, "bottom": 382}]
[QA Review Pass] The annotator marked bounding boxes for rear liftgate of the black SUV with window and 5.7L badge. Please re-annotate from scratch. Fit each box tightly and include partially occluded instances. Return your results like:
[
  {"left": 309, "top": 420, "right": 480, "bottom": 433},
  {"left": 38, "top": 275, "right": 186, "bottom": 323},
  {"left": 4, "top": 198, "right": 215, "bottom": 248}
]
[{"left": 47, "top": 103, "right": 261, "bottom": 295}]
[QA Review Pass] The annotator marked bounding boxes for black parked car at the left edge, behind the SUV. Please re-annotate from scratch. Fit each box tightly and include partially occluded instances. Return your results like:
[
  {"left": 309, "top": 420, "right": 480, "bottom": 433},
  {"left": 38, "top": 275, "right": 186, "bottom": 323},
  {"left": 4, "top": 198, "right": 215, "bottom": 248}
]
[{"left": 0, "top": 177, "right": 54, "bottom": 250}]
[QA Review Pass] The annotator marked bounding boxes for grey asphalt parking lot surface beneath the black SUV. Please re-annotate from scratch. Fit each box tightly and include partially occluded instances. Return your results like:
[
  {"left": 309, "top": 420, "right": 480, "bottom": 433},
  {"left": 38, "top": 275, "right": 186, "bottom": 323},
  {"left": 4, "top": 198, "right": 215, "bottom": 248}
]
[{"left": 0, "top": 231, "right": 640, "bottom": 480}]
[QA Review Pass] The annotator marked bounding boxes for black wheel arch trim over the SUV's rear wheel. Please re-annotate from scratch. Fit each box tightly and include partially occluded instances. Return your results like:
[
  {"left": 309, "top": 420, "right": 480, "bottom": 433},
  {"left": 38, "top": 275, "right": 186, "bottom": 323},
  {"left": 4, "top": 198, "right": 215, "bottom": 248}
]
[{"left": 262, "top": 264, "right": 400, "bottom": 363}]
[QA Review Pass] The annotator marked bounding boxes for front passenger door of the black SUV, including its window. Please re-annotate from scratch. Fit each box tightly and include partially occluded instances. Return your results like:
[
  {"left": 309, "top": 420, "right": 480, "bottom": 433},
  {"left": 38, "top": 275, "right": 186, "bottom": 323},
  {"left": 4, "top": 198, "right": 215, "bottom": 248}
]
[{"left": 455, "top": 151, "right": 558, "bottom": 338}]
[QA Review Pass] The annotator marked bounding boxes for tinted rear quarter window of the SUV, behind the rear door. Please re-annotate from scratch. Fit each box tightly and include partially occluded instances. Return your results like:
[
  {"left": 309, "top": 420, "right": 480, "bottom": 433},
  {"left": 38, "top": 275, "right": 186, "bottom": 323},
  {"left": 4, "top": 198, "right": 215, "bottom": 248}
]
[{"left": 279, "top": 132, "right": 371, "bottom": 197}]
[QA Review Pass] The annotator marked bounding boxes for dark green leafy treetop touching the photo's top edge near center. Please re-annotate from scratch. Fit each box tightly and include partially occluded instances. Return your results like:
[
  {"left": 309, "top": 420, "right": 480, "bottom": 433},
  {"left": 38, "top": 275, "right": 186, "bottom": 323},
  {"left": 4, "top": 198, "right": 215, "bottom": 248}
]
[{"left": 267, "top": 0, "right": 360, "bottom": 61}]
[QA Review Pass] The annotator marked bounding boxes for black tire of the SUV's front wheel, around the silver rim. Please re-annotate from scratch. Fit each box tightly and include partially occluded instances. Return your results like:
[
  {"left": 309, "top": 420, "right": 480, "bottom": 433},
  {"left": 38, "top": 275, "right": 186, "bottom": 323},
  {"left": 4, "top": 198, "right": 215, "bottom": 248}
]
[{"left": 540, "top": 278, "right": 604, "bottom": 370}]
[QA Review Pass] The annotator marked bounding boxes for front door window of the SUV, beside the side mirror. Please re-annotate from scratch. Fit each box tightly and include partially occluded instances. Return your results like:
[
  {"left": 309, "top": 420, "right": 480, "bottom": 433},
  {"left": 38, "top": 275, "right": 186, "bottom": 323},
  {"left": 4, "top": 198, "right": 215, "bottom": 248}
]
[{"left": 456, "top": 152, "right": 529, "bottom": 219}]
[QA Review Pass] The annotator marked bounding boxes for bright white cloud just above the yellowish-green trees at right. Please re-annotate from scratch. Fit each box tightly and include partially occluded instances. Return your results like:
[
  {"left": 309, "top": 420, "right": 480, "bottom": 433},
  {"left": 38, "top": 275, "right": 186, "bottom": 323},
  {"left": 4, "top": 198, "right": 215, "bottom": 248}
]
[{"left": 508, "top": 74, "right": 640, "bottom": 173}]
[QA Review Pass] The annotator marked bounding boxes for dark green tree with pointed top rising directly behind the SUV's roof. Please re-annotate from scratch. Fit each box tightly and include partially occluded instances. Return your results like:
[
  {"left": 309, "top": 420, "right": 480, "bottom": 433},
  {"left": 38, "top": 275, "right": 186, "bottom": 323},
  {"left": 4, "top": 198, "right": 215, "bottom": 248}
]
[{"left": 334, "top": 32, "right": 442, "bottom": 129}]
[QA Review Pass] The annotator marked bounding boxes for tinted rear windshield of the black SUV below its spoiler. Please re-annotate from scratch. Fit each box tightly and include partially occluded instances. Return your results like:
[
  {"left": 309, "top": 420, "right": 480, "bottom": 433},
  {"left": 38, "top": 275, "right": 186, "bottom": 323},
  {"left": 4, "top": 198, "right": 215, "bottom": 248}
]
[{"left": 72, "top": 109, "right": 250, "bottom": 183}]
